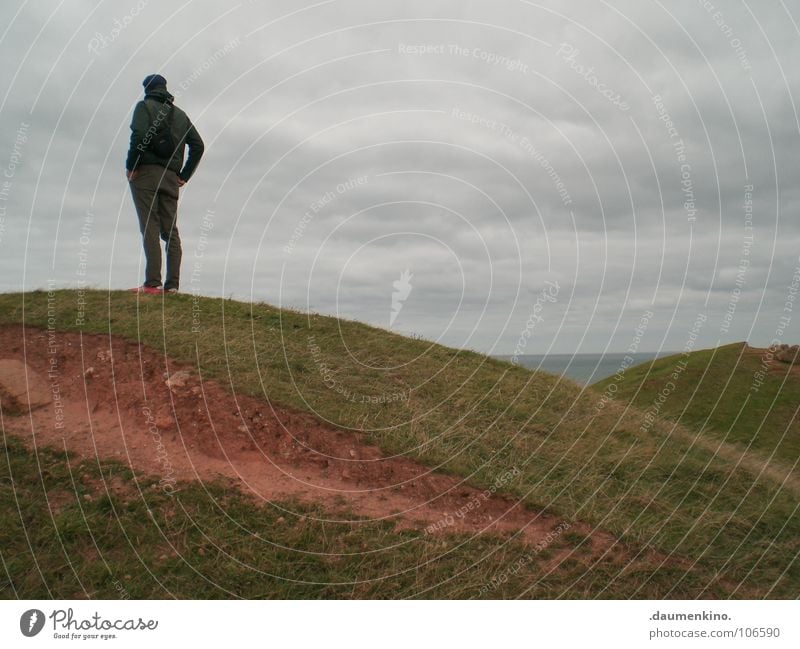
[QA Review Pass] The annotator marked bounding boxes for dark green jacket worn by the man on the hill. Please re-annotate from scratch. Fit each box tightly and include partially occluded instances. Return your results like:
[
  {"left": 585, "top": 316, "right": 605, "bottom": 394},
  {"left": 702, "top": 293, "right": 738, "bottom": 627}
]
[{"left": 125, "top": 86, "right": 203, "bottom": 180}]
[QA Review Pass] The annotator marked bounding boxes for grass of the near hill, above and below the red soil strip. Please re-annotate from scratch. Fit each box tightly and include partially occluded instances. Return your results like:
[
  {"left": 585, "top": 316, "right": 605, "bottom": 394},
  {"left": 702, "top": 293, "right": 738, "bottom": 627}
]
[{"left": 0, "top": 291, "right": 800, "bottom": 598}]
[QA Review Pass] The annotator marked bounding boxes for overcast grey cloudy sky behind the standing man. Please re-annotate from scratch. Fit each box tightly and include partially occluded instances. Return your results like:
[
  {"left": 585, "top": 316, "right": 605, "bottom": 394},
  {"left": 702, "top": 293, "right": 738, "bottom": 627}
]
[{"left": 0, "top": 0, "right": 800, "bottom": 354}]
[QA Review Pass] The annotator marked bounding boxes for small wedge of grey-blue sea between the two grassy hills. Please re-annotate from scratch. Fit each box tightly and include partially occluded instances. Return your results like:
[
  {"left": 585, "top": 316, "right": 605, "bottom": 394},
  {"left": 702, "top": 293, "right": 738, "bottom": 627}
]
[{"left": 495, "top": 351, "right": 677, "bottom": 385}]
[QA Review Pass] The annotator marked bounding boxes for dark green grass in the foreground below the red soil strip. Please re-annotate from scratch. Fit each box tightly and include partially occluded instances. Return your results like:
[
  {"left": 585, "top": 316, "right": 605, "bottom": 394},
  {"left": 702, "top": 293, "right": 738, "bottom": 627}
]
[{"left": 0, "top": 437, "right": 700, "bottom": 599}]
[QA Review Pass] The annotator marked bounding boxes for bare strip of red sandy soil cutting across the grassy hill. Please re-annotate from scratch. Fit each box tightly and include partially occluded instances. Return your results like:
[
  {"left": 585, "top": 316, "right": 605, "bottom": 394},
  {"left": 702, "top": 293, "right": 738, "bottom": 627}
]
[{"left": 0, "top": 327, "right": 644, "bottom": 562}]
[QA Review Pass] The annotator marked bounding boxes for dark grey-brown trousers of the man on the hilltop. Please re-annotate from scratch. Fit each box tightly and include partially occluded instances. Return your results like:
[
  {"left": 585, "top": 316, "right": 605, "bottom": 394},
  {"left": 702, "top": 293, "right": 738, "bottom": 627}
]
[{"left": 130, "top": 165, "right": 181, "bottom": 289}]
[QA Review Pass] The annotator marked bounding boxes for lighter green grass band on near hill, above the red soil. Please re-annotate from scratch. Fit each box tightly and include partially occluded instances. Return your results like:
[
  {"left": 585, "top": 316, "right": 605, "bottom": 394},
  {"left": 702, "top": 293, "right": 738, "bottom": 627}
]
[{"left": 0, "top": 291, "right": 800, "bottom": 597}]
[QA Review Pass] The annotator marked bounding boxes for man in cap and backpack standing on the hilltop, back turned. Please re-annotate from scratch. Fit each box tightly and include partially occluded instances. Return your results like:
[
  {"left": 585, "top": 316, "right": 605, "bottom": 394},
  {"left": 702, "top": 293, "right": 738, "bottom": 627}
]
[{"left": 125, "top": 74, "right": 203, "bottom": 293}]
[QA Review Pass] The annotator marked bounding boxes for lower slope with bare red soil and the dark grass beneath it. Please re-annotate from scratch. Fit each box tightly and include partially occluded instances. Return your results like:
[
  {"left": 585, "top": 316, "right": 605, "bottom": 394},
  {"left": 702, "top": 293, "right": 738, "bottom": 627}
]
[{"left": 0, "top": 326, "right": 676, "bottom": 597}]
